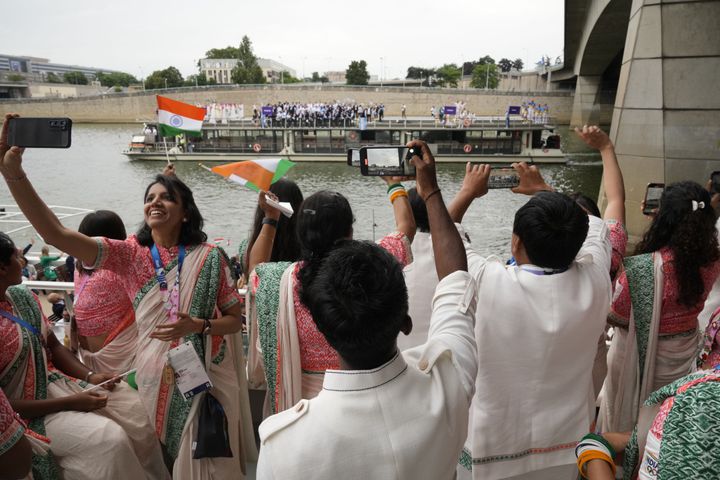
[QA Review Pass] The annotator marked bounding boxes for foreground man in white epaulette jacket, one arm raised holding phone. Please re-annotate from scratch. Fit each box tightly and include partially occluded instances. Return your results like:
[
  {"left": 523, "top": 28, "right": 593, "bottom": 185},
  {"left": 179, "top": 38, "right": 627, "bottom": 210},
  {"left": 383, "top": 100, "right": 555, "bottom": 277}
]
[{"left": 258, "top": 141, "right": 477, "bottom": 480}]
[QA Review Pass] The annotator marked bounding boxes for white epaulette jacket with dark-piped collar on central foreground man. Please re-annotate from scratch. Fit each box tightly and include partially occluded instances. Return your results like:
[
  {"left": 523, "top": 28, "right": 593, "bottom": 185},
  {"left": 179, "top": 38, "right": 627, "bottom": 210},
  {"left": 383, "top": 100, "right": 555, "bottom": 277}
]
[{"left": 257, "top": 272, "right": 477, "bottom": 480}]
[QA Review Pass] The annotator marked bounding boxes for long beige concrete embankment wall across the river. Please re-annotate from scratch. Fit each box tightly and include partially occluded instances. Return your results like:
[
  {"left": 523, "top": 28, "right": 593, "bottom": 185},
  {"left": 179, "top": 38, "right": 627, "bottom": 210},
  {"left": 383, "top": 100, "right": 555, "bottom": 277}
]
[{"left": 0, "top": 85, "right": 573, "bottom": 124}]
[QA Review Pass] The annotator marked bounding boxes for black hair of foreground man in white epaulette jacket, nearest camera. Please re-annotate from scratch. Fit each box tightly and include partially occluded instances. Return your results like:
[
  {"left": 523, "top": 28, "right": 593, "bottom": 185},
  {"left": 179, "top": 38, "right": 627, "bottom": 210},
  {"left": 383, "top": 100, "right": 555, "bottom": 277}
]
[{"left": 300, "top": 240, "right": 408, "bottom": 369}]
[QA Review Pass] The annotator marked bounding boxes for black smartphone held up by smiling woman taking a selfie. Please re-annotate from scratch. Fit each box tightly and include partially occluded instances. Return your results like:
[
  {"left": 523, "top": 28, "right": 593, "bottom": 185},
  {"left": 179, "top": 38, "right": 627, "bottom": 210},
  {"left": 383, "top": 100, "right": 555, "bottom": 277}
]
[{"left": 8, "top": 117, "right": 72, "bottom": 148}]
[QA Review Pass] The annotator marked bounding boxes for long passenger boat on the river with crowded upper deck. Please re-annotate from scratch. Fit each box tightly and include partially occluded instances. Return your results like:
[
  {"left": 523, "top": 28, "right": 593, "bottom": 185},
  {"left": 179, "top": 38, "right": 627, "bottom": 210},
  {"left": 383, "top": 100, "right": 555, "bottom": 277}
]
[{"left": 122, "top": 117, "right": 566, "bottom": 164}]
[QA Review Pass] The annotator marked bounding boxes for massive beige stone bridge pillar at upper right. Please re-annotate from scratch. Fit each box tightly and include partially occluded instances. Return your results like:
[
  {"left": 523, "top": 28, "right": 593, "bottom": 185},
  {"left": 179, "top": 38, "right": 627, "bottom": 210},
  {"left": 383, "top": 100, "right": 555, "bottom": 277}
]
[{"left": 610, "top": 0, "right": 720, "bottom": 238}]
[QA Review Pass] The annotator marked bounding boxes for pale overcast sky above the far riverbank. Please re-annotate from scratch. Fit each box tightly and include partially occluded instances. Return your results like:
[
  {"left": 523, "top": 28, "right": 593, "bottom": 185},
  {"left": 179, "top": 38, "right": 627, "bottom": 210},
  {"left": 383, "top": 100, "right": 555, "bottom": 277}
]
[{"left": 0, "top": 0, "right": 564, "bottom": 79}]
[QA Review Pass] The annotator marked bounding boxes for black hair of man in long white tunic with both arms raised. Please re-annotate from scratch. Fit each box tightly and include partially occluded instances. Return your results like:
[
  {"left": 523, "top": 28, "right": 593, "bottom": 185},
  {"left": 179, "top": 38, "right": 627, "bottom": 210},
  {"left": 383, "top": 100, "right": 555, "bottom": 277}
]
[{"left": 513, "top": 192, "right": 589, "bottom": 269}]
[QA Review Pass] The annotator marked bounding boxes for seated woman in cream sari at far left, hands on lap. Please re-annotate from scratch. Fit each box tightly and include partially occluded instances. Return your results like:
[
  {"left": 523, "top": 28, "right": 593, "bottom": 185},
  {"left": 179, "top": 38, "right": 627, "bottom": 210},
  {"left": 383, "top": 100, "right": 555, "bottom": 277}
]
[{"left": 0, "top": 233, "right": 168, "bottom": 480}]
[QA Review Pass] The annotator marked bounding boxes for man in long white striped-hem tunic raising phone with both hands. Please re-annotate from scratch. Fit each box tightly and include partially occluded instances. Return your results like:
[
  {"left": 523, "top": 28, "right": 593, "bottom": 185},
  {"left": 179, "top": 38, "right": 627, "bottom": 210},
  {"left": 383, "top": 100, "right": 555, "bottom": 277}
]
[{"left": 449, "top": 163, "right": 612, "bottom": 480}]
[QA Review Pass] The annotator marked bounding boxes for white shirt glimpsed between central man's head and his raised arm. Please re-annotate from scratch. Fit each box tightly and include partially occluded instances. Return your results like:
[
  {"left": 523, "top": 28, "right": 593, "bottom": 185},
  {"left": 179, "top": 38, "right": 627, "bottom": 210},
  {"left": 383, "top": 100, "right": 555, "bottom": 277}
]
[{"left": 398, "top": 232, "right": 438, "bottom": 350}]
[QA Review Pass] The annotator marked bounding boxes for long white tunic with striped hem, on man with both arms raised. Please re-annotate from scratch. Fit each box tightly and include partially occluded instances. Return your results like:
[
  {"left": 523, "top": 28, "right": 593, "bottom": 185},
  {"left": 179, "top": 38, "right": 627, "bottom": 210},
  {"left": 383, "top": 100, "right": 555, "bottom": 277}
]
[{"left": 459, "top": 216, "right": 611, "bottom": 480}]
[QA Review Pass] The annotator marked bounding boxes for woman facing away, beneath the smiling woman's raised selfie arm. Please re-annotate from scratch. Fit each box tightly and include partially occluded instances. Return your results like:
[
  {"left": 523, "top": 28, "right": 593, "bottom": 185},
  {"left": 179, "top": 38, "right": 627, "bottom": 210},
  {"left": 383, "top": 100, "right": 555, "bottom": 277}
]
[{"left": 73, "top": 210, "right": 137, "bottom": 373}]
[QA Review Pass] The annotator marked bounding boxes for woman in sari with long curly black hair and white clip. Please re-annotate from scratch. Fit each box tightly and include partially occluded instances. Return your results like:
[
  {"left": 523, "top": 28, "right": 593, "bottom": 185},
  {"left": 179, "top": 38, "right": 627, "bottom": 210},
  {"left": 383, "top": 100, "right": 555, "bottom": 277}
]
[{"left": 598, "top": 182, "right": 720, "bottom": 432}]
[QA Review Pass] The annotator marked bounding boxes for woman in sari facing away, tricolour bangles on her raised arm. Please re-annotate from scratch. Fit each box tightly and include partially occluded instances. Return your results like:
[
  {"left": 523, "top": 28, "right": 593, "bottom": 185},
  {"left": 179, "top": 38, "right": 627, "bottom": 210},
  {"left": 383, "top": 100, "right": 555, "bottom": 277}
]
[{"left": 249, "top": 179, "right": 415, "bottom": 416}]
